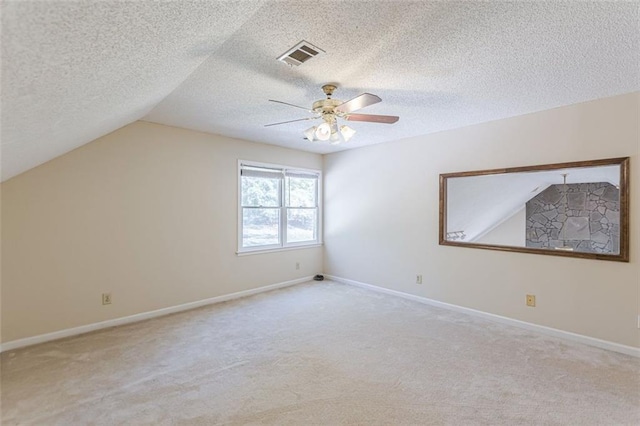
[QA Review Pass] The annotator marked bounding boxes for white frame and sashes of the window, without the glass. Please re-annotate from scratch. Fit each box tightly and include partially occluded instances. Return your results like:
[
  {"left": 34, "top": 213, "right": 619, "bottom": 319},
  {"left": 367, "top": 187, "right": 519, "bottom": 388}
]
[{"left": 236, "top": 160, "right": 323, "bottom": 255}]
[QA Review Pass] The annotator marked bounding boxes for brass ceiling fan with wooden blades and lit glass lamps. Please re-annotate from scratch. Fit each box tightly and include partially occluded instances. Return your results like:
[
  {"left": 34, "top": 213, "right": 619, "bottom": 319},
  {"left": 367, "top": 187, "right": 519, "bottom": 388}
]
[{"left": 265, "top": 84, "right": 400, "bottom": 145}]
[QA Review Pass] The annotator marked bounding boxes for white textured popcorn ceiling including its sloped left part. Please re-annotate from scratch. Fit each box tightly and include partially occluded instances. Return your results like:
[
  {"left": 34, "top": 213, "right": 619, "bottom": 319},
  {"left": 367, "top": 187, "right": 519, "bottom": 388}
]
[{"left": 1, "top": 0, "right": 640, "bottom": 180}]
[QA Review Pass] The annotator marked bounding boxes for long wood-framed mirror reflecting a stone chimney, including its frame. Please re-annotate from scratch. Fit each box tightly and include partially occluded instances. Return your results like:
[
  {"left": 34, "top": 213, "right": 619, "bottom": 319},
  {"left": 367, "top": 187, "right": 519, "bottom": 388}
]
[{"left": 440, "top": 157, "right": 629, "bottom": 262}]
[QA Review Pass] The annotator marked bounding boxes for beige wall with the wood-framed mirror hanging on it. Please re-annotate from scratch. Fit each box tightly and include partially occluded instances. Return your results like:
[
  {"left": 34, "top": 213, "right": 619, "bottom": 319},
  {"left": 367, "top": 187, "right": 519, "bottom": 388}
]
[{"left": 324, "top": 93, "right": 640, "bottom": 347}]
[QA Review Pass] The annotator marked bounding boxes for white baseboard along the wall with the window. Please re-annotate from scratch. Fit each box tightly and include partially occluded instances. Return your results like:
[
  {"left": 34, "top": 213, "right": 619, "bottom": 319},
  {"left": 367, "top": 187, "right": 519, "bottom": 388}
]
[{"left": 0, "top": 276, "right": 313, "bottom": 352}]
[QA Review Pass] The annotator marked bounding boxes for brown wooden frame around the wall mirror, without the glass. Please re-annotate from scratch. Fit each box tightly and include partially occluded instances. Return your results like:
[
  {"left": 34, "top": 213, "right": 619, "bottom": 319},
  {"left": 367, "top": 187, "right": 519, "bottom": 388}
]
[{"left": 439, "top": 157, "right": 630, "bottom": 262}]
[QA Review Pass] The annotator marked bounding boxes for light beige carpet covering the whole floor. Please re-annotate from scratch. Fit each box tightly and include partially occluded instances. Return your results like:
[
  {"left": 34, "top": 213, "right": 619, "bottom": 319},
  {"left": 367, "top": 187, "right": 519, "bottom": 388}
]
[{"left": 2, "top": 281, "right": 640, "bottom": 426}]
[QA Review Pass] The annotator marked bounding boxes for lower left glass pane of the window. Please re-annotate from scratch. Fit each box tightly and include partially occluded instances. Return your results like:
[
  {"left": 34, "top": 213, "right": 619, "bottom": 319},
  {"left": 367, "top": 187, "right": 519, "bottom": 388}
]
[{"left": 242, "top": 209, "right": 280, "bottom": 247}]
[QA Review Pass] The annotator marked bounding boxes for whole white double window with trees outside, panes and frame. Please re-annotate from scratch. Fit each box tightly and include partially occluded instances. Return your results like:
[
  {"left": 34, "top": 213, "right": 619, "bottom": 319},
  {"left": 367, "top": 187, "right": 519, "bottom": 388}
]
[{"left": 238, "top": 161, "right": 321, "bottom": 252}]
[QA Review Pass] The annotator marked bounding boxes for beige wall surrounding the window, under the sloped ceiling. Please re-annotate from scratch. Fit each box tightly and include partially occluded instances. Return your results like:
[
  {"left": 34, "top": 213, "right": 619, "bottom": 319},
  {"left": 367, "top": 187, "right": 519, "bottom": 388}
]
[{"left": 1, "top": 122, "right": 322, "bottom": 342}]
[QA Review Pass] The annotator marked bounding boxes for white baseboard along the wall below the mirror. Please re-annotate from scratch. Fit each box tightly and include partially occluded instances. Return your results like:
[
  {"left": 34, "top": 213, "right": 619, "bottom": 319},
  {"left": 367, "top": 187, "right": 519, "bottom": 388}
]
[{"left": 325, "top": 275, "right": 640, "bottom": 358}]
